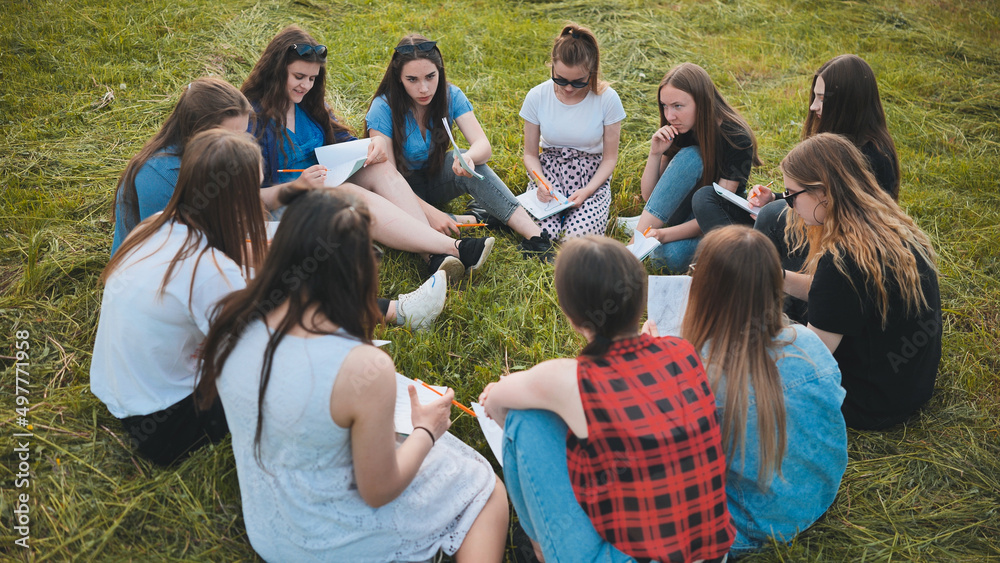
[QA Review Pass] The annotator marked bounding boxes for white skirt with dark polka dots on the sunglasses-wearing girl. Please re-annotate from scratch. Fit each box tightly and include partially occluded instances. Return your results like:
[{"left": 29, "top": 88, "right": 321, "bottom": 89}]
[{"left": 528, "top": 147, "right": 611, "bottom": 240}]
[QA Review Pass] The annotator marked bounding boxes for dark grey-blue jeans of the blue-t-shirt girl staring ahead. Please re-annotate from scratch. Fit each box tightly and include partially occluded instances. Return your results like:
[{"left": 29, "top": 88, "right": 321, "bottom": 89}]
[{"left": 406, "top": 151, "right": 520, "bottom": 224}]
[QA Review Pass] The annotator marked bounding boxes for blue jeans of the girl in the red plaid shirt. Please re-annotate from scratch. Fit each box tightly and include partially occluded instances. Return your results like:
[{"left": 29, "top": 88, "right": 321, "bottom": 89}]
[{"left": 503, "top": 410, "right": 635, "bottom": 563}]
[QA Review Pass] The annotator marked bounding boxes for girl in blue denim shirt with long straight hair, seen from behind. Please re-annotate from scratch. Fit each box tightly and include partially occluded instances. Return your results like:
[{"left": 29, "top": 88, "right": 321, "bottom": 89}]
[{"left": 681, "top": 226, "right": 847, "bottom": 553}]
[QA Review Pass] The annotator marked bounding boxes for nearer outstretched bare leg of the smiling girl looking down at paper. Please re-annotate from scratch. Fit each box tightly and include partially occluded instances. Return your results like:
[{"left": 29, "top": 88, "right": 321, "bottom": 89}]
[{"left": 332, "top": 184, "right": 458, "bottom": 257}]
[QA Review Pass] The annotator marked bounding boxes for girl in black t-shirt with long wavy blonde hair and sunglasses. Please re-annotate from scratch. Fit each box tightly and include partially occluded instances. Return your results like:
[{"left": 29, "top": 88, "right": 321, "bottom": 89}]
[{"left": 781, "top": 133, "right": 941, "bottom": 429}]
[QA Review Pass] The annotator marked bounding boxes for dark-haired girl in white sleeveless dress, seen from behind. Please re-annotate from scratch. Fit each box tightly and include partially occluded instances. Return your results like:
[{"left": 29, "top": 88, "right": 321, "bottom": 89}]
[{"left": 198, "top": 190, "right": 508, "bottom": 562}]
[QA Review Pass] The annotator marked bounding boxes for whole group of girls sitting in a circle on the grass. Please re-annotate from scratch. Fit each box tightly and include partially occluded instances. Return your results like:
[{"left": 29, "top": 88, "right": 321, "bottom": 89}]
[{"left": 91, "top": 19, "right": 942, "bottom": 562}]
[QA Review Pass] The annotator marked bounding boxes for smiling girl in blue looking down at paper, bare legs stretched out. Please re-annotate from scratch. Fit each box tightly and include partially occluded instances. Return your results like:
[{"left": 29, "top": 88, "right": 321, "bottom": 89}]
[{"left": 242, "top": 25, "right": 493, "bottom": 278}]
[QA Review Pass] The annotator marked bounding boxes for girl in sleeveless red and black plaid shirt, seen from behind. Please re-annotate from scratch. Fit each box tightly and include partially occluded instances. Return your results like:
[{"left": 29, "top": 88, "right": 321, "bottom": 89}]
[{"left": 480, "top": 236, "right": 735, "bottom": 563}]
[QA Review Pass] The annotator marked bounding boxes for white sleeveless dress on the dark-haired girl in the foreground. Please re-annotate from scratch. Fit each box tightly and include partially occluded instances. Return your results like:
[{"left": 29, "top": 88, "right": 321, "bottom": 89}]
[{"left": 218, "top": 321, "right": 494, "bottom": 562}]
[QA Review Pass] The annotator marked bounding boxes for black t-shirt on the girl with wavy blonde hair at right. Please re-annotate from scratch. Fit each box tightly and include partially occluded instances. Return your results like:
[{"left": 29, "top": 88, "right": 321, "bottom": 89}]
[{"left": 809, "top": 248, "right": 941, "bottom": 429}]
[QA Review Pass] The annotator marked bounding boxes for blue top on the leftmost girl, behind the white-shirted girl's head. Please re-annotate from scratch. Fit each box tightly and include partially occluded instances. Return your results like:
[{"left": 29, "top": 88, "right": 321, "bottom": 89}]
[{"left": 111, "top": 147, "right": 181, "bottom": 256}]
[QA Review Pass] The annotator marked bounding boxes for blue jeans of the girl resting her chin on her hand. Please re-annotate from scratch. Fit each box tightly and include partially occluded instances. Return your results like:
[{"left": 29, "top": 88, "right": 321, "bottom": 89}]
[{"left": 644, "top": 147, "right": 702, "bottom": 273}]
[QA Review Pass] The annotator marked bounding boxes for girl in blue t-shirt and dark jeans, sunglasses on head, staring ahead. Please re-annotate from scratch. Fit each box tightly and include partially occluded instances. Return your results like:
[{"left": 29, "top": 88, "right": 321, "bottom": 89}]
[{"left": 365, "top": 34, "right": 551, "bottom": 256}]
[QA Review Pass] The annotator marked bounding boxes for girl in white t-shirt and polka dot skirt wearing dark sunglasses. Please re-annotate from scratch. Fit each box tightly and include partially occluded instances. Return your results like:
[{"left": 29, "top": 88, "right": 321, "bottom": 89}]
[{"left": 521, "top": 23, "right": 625, "bottom": 240}]
